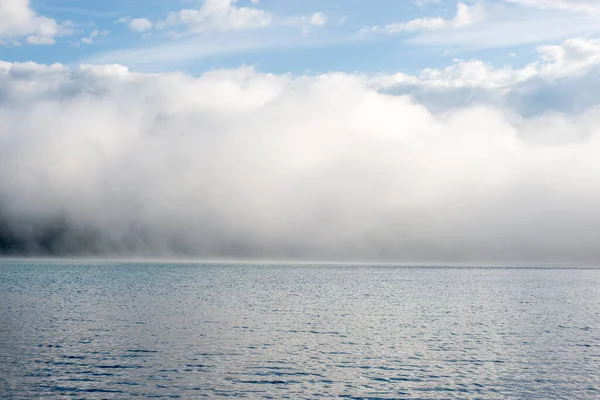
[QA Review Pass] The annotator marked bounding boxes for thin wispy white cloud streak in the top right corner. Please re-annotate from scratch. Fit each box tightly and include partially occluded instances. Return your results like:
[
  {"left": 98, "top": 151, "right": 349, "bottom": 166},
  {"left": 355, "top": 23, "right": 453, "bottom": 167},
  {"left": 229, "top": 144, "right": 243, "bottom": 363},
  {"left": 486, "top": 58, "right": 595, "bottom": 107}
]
[{"left": 359, "top": 0, "right": 600, "bottom": 51}]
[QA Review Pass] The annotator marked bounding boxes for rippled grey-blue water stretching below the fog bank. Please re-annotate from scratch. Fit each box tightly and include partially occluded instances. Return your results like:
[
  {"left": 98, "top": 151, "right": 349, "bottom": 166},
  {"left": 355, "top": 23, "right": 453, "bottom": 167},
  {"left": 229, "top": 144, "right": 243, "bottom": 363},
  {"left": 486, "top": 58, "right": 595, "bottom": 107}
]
[{"left": 0, "top": 261, "right": 600, "bottom": 399}]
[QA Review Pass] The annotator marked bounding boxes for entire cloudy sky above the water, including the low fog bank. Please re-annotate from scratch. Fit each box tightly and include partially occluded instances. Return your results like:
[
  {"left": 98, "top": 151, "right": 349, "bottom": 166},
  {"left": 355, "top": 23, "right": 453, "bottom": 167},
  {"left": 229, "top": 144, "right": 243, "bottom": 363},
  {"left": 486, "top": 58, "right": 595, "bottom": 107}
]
[{"left": 0, "top": 0, "right": 600, "bottom": 265}]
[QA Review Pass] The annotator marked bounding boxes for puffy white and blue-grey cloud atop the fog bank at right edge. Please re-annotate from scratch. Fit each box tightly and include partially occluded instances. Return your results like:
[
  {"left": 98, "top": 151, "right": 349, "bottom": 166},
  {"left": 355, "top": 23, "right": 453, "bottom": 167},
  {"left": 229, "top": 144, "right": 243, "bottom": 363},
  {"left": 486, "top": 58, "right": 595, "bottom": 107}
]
[{"left": 372, "top": 39, "right": 600, "bottom": 115}]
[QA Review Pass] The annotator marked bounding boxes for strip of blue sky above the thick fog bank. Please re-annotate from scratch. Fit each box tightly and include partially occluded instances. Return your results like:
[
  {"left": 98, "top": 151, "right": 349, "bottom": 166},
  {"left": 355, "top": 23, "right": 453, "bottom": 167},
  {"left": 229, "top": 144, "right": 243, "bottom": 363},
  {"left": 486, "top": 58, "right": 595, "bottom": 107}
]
[{"left": 0, "top": 0, "right": 600, "bottom": 74}]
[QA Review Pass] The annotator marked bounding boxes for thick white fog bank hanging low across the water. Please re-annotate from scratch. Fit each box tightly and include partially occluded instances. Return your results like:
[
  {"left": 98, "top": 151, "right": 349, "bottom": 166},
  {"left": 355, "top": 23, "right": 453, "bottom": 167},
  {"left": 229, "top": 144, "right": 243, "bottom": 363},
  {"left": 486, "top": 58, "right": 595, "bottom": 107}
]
[{"left": 0, "top": 41, "right": 600, "bottom": 263}]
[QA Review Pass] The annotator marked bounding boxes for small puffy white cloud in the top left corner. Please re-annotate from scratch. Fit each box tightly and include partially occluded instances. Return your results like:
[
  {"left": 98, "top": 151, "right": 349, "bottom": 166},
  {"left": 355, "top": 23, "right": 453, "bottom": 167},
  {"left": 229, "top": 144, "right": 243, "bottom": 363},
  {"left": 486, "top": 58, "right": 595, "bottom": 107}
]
[{"left": 0, "top": 0, "right": 71, "bottom": 44}]
